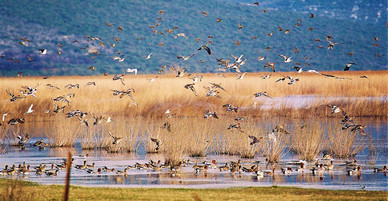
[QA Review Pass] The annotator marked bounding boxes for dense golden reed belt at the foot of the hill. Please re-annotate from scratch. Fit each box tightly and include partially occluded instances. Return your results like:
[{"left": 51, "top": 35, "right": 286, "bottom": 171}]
[{"left": 0, "top": 71, "right": 388, "bottom": 118}]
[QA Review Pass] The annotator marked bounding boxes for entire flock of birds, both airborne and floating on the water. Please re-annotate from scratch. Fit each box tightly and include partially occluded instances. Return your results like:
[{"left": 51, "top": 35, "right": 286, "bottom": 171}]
[{"left": 0, "top": 2, "right": 388, "bottom": 184}]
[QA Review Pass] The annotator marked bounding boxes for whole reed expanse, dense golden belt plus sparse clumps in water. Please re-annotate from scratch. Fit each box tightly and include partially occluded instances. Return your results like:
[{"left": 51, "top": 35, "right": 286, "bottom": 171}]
[{"left": 0, "top": 71, "right": 388, "bottom": 164}]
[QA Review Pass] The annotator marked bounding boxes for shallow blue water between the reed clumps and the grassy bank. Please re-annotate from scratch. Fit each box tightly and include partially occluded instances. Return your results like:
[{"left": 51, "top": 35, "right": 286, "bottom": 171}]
[{"left": 0, "top": 119, "right": 388, "bottom": 191}]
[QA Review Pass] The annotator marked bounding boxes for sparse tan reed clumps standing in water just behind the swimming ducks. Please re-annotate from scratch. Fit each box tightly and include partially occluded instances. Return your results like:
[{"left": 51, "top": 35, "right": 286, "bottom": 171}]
[{"left": 0, "top": 115, "right": 372, "bottom": 165}]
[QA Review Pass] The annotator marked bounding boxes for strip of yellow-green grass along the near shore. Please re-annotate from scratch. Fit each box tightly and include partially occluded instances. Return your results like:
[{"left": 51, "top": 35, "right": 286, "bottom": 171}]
[{"left": 0, "top": 179, "right": 388, "bottom": 200}]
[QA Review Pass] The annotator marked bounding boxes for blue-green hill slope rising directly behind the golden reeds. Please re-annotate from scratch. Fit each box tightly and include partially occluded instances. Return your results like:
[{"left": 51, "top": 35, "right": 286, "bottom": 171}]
[{"left": 0, "top": 0, "right": 387, "bottom": 76}]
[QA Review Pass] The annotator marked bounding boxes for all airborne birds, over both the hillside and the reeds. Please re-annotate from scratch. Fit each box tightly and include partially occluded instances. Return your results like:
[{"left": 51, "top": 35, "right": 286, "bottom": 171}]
[{"left": 2, "top": 2, "right": 379, "bottom": 154}]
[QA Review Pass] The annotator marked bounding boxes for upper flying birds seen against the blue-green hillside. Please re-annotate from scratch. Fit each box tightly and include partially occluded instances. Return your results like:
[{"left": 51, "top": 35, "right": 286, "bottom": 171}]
[{"left": 1, "top": 2, "right": 388, "bottom": 79}]
